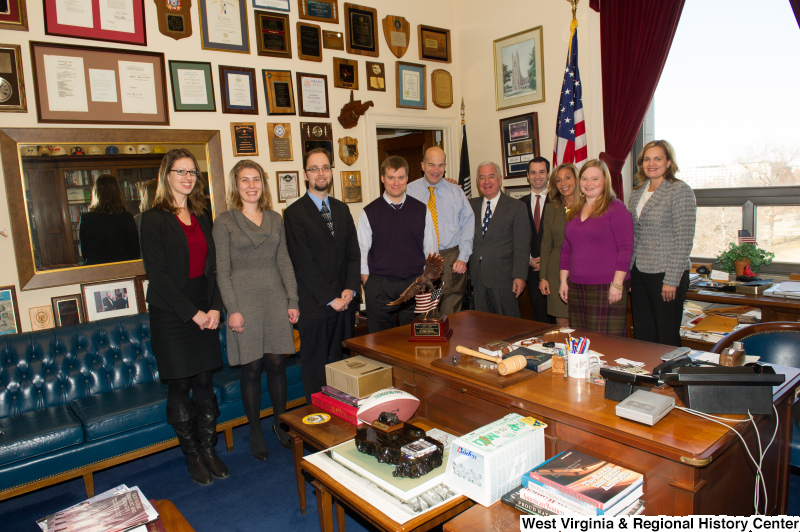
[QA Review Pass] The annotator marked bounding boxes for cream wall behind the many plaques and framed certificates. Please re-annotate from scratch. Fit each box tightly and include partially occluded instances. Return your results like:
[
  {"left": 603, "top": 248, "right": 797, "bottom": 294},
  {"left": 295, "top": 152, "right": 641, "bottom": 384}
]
[{"left": 0, "top": 0, "right": 602, "bottom": 331}]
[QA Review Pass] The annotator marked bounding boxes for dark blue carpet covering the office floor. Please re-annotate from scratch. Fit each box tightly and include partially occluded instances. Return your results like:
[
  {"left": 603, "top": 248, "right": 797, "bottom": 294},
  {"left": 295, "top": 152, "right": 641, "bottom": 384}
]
[{"left": 0, "top": 417, "right": 800, "bottom": 532}]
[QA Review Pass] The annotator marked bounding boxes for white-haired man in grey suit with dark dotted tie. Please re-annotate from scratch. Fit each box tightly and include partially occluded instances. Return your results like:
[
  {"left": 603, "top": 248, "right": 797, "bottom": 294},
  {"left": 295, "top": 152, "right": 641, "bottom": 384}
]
[{"left": 469, "top": 162, "right": 531, "bottom": 318}]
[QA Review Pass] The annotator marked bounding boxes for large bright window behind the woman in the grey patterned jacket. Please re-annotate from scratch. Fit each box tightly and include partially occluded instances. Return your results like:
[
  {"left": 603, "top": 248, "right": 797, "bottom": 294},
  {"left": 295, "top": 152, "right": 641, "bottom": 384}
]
[{"left": 648, "top": 0, "right": 800, "bottom": 273}]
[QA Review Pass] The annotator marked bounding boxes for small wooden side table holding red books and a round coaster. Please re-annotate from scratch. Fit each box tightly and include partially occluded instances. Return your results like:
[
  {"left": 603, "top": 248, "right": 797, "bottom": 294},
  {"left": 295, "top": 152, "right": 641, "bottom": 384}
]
[{"left": 280, "top": 405, "right": 356, "bottom": 515}]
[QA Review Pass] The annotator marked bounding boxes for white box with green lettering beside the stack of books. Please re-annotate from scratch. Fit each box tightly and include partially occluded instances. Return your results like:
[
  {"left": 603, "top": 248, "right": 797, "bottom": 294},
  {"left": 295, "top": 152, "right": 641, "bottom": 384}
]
[{"left": 444, "top": 414, "right": 547, "bottom": 506}]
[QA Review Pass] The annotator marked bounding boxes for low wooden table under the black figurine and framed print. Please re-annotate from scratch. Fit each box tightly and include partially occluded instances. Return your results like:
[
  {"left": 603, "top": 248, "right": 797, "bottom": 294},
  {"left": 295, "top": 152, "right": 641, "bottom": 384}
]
[{"left": 300, "top": 418, "right": 474, "bottom": 532}]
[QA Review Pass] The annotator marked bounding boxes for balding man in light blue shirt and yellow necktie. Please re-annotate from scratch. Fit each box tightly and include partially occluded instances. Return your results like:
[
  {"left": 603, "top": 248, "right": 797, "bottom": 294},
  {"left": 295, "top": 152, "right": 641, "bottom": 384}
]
[{"left": 407, "top": 146, "right": 475, "bottom": 314}]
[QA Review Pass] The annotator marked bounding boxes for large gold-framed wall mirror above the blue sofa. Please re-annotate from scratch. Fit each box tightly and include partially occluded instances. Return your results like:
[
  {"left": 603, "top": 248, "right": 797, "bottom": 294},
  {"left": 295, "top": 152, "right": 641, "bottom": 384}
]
[{"left": 0, "top": 128, "right": 226, "bottom": 290}]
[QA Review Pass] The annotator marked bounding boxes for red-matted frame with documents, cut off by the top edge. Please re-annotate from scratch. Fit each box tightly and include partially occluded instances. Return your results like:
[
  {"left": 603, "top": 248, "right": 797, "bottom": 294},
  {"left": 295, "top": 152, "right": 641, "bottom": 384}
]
[{"left": 44, "top": 0, "right": 147, "bottom": 46}]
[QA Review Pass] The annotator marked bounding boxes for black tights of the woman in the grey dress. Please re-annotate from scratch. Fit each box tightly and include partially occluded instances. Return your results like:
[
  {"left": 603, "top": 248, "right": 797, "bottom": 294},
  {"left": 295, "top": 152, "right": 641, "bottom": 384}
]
[{"left": 242, "top": 353, "right": 286, "bottom": 432}]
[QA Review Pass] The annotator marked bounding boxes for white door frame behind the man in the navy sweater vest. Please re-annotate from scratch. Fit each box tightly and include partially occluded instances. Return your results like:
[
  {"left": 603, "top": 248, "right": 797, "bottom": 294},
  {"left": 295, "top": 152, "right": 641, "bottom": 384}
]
[{"left": 361, "top": 112, "right": 461, "bottom": 203}]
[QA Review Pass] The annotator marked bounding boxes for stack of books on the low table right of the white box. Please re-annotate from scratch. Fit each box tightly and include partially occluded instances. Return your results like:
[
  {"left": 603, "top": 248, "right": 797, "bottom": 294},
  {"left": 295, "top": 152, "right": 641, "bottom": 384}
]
[{"left": 501, "top": 451, "right": 644, "bottom": 516}]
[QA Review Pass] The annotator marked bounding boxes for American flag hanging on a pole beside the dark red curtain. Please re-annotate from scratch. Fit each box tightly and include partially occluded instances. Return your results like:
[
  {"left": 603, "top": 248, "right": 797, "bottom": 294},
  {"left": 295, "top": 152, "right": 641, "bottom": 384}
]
[{"left": 553, "top": 19, "right": 587, "bottom": 166}]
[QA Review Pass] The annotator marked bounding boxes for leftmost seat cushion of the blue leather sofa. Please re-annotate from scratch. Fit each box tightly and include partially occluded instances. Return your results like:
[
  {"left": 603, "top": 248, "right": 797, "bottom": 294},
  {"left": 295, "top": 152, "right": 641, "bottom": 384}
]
[{"left": 0, "top": 405, "right": 84, "bottom": 466}]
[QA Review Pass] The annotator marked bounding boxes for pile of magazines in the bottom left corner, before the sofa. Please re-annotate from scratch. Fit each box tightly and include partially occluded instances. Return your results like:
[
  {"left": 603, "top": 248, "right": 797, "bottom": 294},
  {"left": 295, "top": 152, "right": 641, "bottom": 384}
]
[{"left": 36, "top": 484, "right": 165, "bottom": 532}]
